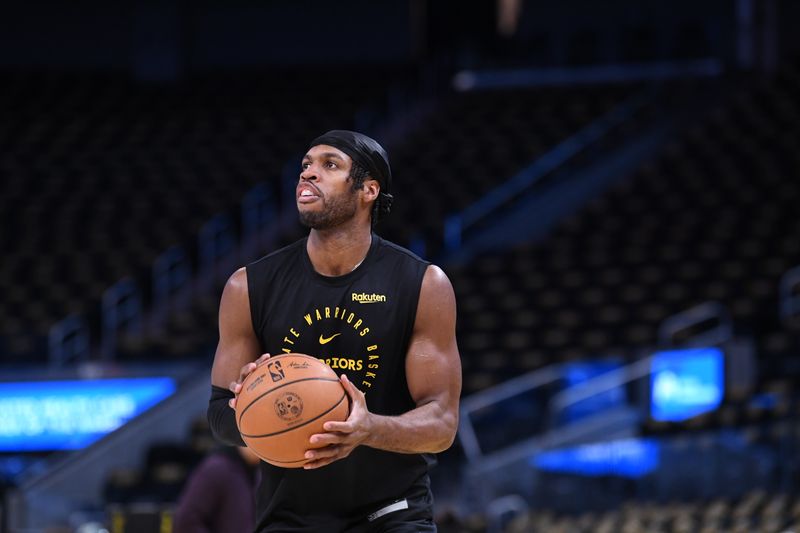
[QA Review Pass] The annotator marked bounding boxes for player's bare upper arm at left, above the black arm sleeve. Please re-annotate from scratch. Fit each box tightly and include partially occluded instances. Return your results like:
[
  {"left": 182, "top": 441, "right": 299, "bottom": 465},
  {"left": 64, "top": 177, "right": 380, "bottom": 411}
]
[{"left": 211, "top": 268, "right": 261, "bottom": 388}]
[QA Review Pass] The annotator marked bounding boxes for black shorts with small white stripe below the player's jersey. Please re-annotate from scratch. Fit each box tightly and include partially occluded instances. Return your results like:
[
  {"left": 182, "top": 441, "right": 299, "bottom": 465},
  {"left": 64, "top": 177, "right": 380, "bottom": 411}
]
[{"left": 347, "top": 494, "right": 436, "bottom": 533}]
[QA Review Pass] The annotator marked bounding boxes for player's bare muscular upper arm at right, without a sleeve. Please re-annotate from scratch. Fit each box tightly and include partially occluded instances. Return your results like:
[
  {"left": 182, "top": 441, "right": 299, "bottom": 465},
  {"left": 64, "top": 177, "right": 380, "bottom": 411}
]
[{"left": 406, "top": 266, "right": 461, "bottom": 408}]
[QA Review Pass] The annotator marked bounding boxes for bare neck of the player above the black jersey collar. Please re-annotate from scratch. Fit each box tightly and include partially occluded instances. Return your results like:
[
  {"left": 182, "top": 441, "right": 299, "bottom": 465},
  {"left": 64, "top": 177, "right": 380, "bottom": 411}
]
[{"left": 306, "top": 225, "right": 372, "bottom": 276}]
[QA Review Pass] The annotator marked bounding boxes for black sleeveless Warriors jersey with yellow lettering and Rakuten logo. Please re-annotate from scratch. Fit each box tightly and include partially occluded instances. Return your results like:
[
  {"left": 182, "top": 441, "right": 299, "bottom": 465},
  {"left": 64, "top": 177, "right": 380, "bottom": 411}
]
[{"left": 246, "top": 234, "right": 433, "bottom": 532}]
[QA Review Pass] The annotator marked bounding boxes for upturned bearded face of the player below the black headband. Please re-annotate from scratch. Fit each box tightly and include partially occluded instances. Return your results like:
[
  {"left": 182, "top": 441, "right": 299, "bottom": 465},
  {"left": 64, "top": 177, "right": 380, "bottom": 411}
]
[{"left": 296, "top": 144, "right": 358, "bottom": 230}]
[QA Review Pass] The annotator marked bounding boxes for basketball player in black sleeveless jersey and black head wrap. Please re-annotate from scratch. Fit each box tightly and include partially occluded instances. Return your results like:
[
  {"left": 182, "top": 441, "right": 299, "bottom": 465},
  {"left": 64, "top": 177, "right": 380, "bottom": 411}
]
[{"left": 209, "top": 130, "right": 461, "bottom": 533}]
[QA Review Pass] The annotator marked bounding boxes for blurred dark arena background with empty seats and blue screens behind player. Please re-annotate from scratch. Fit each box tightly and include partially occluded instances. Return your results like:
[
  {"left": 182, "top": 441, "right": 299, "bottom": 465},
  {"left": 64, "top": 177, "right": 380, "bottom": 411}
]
[{"left": 0, "top": 0, "right": 800, "bottom": 533}]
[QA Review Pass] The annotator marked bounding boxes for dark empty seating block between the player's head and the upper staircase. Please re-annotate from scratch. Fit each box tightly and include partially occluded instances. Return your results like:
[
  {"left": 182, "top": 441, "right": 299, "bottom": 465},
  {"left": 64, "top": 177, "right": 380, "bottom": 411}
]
[{"left": 380, "top": 85, "right": 634, "bottom": 252}]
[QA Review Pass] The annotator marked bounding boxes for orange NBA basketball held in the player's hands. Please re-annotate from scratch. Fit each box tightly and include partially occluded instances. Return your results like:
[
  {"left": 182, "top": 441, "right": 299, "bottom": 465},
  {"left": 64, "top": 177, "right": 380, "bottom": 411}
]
[{"left": 236, "top": 353, "right": 350, "bottom": 468}]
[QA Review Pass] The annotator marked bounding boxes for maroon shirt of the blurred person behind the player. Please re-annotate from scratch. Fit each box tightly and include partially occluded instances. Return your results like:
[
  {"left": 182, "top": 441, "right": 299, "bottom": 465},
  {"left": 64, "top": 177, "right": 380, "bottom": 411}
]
[{"left": 174, "top": 448, "right": 255, "bottom": 533}]
